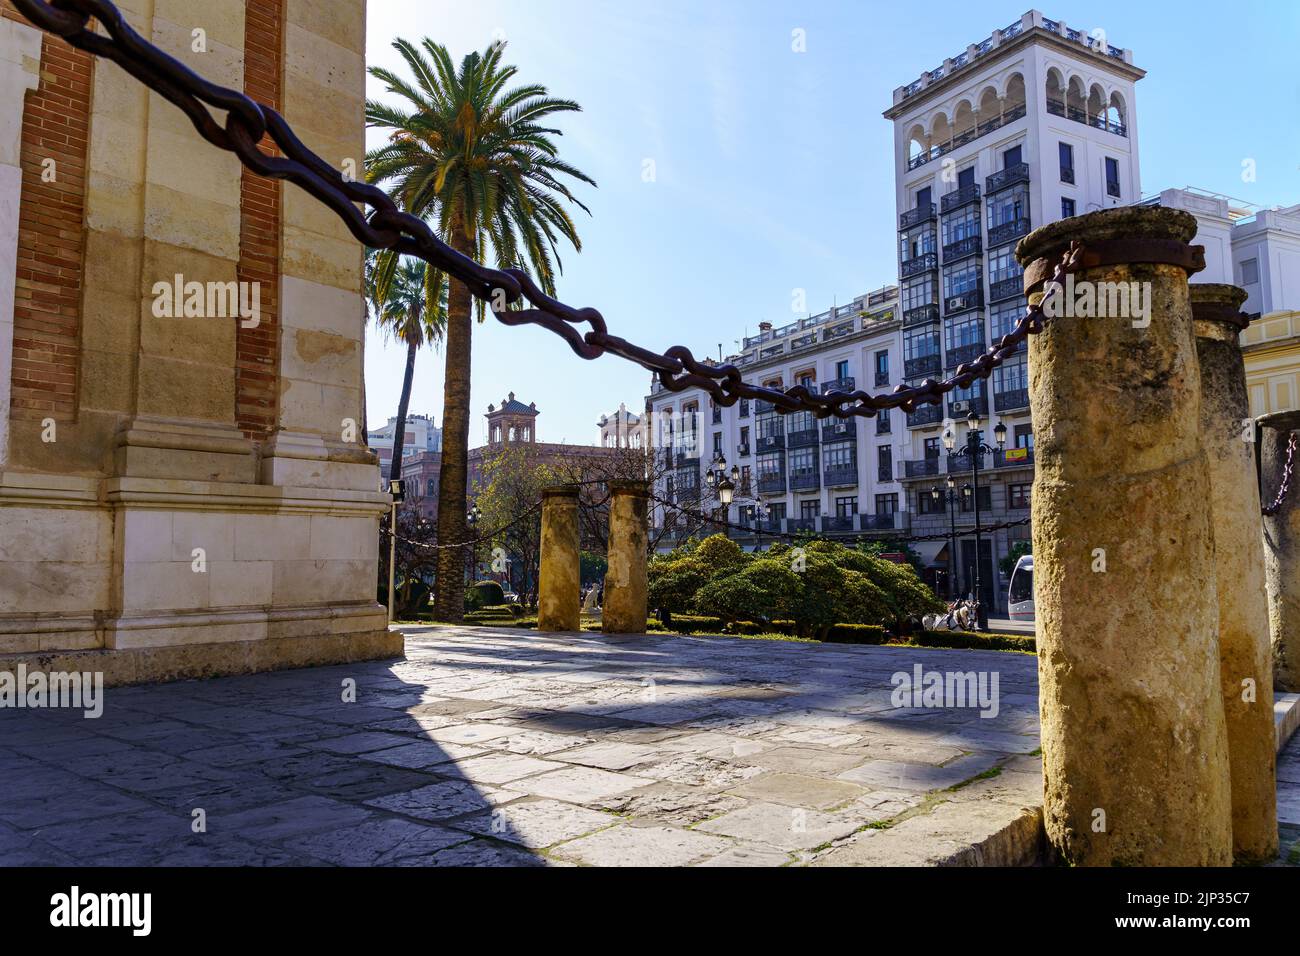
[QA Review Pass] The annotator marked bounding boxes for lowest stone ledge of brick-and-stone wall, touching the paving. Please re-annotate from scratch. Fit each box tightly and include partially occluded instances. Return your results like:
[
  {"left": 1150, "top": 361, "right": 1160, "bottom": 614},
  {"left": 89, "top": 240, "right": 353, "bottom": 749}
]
[{"left": 0, "top": 627, "right": 404, "bottom": 687}]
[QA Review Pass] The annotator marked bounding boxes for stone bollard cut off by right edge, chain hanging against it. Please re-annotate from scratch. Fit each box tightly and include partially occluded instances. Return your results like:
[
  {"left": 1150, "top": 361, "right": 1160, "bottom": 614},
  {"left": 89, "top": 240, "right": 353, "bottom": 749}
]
[{"left": 1257, "top": 411, "right": 1300, "bottom": 693}]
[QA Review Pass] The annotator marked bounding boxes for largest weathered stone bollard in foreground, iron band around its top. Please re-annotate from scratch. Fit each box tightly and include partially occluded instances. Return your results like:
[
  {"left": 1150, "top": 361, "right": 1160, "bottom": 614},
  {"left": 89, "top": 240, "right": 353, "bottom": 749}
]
[{"left": 1017, "top": 207, "right": 1232, "bottom": 866}]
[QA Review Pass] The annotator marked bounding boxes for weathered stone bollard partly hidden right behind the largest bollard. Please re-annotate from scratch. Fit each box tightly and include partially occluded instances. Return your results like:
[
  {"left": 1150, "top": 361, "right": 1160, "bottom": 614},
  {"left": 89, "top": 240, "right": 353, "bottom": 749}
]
[{"left": 1188, "top": 282, "right": 1278, "bottom": 864}]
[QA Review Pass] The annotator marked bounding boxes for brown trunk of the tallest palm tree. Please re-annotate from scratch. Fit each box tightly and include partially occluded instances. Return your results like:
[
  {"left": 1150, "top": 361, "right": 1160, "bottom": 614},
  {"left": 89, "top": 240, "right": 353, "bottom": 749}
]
[{"left": 433, "top": 229, "right": 475, "bottom": 622}]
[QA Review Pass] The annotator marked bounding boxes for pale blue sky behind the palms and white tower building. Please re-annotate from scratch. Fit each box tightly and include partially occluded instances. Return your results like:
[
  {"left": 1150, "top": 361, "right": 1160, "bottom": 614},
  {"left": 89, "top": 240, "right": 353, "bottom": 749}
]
[{"left": 367, "top": 0, "right": 1300, "bottom": 444}]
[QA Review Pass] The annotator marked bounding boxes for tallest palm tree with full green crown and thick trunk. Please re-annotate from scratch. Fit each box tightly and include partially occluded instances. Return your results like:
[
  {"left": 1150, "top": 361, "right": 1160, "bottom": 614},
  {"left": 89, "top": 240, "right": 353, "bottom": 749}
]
[{"left": 365, "top": 38, "right": 595, "bottom": 620}]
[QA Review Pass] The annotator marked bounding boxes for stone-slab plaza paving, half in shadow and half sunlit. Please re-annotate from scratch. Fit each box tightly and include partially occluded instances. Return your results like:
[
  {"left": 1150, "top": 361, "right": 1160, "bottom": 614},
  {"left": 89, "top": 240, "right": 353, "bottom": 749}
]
[{"left": 0, "top": 627, "right": 1300, "bottom": 866}]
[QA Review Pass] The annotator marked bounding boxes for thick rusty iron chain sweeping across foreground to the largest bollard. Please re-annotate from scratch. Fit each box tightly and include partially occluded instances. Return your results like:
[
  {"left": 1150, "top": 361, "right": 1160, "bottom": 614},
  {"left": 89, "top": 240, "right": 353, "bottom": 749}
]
[{"left": 13, "top": 0, "right": 1083, "bottom": 419}]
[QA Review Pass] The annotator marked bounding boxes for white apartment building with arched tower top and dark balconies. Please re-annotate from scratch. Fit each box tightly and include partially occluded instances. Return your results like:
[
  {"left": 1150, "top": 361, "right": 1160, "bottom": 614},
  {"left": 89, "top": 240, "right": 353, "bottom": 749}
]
[{"left": 647, "top": 10, "right": 1144, "bottom": 609}]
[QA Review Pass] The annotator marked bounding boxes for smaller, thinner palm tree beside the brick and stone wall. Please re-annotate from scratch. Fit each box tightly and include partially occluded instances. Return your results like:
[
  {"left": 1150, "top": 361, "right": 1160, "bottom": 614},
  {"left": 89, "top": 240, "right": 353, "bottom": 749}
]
[{"left": 367, "top": 252, "right": 446, "bottom": 481}]
